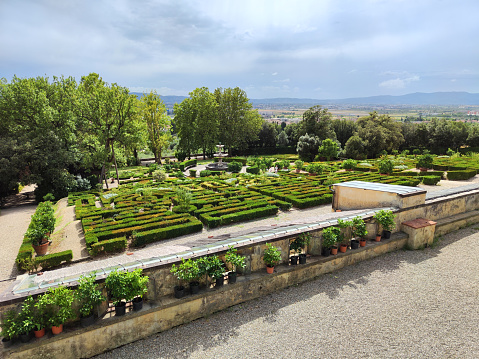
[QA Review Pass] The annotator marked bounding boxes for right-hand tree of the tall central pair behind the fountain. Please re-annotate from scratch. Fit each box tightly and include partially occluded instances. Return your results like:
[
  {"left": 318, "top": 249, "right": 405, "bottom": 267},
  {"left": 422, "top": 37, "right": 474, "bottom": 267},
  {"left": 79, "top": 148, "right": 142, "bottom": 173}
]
[{"left": 214, "top": 87, "right": 263, "bottom": 154}]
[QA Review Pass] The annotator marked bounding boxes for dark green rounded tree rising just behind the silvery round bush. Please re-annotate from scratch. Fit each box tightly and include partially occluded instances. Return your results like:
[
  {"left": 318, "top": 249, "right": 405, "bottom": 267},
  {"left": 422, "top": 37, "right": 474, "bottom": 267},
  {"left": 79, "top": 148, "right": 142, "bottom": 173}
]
[{"left": 300, "top": 105, "right": 336, "bottom": 140}]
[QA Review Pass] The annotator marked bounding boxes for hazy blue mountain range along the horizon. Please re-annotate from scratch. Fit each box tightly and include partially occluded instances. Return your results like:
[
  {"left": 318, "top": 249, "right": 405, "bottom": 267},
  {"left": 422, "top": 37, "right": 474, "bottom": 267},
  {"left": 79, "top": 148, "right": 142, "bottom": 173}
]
[{"left": 133, "top": 92, "right": 479, "bottom": 106}]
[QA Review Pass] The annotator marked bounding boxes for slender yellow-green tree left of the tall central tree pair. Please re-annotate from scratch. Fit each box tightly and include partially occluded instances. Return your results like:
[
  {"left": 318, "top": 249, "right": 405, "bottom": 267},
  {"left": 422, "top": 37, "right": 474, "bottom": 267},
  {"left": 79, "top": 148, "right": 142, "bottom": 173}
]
[{"left": 140, "top": 91, "right": 172, "bottom": 163}]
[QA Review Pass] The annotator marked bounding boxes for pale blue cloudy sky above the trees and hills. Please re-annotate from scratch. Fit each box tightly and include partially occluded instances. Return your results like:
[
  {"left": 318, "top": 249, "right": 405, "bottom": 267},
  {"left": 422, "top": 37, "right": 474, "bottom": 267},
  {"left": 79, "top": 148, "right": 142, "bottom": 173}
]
[{"left": 0, "top": 0, "right": 479, "bottom": 99}]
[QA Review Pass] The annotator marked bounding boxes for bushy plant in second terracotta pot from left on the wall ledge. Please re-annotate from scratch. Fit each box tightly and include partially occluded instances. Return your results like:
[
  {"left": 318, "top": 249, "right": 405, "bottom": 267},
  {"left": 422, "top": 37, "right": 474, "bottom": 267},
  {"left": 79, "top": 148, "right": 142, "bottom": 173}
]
[{"left": 41, "top": 286, "right": 75, "bottom": 335}]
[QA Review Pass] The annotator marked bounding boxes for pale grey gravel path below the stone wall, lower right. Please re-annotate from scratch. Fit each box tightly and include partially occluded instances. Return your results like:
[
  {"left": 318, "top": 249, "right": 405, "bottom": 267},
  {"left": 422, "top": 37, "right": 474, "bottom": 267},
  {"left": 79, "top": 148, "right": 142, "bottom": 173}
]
[{"left": 97, "top": 227, "right": 479, "bottom": 359}]
